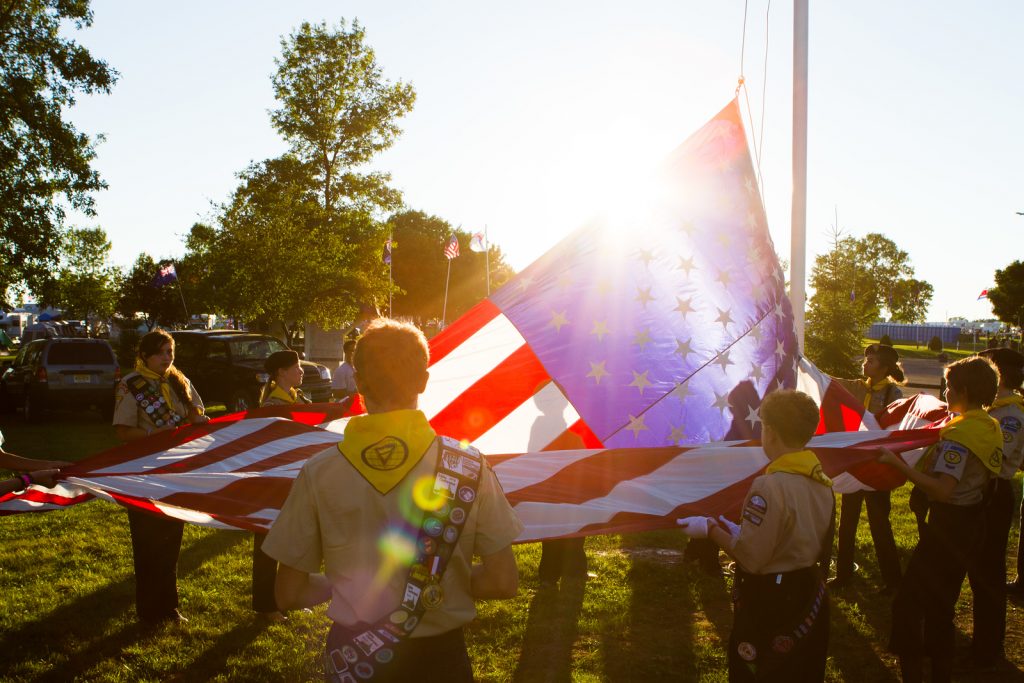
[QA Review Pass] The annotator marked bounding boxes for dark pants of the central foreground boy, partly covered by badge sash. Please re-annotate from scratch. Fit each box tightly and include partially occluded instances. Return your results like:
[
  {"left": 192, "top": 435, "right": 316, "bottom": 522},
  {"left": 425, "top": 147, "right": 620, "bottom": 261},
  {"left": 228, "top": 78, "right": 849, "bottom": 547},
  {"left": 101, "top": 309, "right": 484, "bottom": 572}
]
[{"left": 324, "top": 624, "right": 473, "bottom": 683}]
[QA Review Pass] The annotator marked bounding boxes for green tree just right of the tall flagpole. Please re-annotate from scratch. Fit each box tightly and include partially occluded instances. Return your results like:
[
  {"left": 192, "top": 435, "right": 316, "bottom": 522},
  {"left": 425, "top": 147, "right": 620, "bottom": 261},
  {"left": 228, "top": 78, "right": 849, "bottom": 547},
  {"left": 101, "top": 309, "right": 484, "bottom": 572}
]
[{"left": 806, "top": 231, "right": 932, "bottom": 377}]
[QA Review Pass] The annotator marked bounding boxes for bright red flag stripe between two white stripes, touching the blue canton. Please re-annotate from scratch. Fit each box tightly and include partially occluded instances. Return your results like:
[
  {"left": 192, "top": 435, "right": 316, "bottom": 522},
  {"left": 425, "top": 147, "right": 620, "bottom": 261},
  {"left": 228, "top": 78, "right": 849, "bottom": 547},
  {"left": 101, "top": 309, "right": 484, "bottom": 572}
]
[{"left": 430, "top": 345, "right": 551, "bottom": 441}]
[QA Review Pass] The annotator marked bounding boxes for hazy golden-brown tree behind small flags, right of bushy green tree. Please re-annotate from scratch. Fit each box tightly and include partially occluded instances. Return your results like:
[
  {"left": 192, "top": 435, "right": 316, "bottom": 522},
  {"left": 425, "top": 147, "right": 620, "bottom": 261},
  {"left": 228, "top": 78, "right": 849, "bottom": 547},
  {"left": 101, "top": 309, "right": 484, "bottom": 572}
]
[{"left": 383, "top": 211, "right": 514, "bottom": 321}]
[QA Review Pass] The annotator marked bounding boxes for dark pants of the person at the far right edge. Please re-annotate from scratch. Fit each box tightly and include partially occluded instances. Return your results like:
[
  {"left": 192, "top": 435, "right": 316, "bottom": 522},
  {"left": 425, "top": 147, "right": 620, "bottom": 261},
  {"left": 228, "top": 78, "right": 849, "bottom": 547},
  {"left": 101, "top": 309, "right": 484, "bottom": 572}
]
[{"left": 967, "top": 478, "right": 1014, "bottom": 659}]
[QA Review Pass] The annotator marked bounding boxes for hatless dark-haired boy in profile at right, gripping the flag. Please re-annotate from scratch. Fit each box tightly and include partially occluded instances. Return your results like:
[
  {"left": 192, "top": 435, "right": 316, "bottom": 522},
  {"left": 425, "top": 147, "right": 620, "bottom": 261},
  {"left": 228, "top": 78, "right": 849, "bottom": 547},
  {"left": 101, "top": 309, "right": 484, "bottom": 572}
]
[{"left": 879, "top": 356, "right": 1002, "bottom": 683}]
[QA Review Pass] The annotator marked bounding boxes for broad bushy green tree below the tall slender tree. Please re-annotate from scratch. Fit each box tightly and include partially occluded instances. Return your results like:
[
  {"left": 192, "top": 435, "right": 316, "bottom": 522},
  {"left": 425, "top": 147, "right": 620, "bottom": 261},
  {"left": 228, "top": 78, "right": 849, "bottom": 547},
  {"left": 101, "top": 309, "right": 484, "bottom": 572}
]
[{"left": 194, "top": 155, "right": 387, "bottom": 329}]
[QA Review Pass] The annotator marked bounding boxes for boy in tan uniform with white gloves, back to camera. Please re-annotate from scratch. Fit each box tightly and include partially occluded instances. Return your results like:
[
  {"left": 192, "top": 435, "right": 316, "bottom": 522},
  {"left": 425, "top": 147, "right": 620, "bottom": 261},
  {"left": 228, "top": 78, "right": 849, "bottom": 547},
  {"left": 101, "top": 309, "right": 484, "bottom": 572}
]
[{"left": 679, "top": 390, "right": 836, "bottom": 683}]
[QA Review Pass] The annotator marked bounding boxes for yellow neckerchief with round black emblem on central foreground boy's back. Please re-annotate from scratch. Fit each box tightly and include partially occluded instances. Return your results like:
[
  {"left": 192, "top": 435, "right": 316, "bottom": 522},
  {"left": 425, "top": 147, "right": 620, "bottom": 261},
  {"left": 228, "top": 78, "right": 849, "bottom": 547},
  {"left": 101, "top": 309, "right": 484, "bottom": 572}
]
[{"left": 338, "top": 411, "right": 437, "bottom": 494}]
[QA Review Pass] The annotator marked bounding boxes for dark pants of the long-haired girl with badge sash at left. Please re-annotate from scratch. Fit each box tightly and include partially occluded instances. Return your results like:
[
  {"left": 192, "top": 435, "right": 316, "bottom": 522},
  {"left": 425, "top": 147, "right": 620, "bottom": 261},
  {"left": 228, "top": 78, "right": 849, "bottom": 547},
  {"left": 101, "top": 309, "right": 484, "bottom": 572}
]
[{"left": 128, "top": 508, "right": 184, "bottom": 622}]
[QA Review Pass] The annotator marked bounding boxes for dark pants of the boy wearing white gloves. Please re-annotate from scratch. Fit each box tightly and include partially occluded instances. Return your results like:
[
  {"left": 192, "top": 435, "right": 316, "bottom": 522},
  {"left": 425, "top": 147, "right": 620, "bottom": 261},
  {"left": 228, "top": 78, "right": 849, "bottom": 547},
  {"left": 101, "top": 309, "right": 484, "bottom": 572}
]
[{"left": 728, "top": 566, "right": 829, "bottom": 683}]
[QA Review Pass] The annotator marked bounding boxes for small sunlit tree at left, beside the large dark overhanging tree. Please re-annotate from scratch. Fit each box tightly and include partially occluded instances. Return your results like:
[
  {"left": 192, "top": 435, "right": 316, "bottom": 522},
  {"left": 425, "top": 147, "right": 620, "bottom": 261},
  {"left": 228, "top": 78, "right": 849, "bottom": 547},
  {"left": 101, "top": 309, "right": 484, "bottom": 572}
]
[{"left": 36, "top": 227, "right": 123, "bottom": 321}]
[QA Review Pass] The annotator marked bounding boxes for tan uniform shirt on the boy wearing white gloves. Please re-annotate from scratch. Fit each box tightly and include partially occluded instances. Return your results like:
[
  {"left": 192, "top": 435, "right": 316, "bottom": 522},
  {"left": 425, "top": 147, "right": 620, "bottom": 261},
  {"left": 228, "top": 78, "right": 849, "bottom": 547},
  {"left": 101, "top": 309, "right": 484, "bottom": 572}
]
[{"left": 732, "top": 472, "right": 834, "bottom": 574}]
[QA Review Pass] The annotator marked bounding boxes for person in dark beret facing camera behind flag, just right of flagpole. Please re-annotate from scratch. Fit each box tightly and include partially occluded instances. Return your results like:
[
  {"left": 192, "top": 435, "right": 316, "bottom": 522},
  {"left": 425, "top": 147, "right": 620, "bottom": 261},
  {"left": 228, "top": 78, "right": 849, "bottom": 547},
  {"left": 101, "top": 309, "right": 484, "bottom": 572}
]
[{"left": 828, "top": 344, "right": 905, "bottom": 594}]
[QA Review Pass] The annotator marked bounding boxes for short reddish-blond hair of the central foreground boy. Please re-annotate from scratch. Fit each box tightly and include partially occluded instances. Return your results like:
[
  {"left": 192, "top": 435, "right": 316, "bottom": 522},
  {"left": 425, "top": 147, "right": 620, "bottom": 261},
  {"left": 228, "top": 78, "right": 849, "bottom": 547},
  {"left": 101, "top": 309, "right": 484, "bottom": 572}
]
[{"left": 352, "top": 317, "right": 430, "bottom": 402}]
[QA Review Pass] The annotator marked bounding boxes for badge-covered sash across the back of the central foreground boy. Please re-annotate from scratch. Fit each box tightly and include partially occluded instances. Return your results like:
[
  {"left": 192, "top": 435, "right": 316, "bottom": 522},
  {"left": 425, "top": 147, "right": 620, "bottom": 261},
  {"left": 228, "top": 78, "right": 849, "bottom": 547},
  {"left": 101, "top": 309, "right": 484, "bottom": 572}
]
[{"left": 325, "top": 436, "right": 483, "bottom": 683}]
